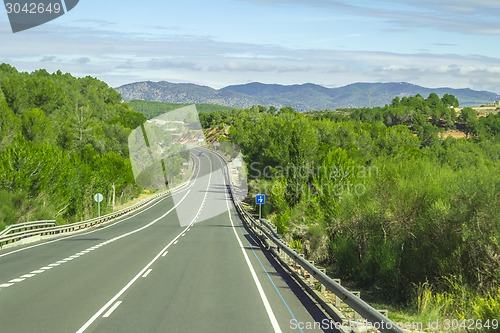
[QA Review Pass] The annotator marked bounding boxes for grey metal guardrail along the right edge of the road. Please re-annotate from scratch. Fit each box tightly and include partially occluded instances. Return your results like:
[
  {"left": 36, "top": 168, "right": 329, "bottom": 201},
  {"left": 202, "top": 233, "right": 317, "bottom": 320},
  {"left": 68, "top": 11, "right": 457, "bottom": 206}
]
[{"left": 209, "top": 152, "right": 404, "bottom": 333}]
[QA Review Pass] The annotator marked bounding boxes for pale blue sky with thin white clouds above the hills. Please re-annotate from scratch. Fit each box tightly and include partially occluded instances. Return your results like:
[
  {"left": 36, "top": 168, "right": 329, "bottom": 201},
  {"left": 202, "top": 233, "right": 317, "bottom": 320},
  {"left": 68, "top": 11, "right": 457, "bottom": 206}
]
[{"left": 0, "top": 0, "right": 500, "bottom": 93}]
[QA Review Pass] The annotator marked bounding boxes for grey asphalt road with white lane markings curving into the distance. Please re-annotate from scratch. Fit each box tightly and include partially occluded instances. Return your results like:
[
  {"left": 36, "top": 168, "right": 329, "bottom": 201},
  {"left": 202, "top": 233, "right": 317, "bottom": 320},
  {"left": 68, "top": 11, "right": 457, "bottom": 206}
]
[{"left": 0, "top": 151, "right": 338, "bottom": 333}]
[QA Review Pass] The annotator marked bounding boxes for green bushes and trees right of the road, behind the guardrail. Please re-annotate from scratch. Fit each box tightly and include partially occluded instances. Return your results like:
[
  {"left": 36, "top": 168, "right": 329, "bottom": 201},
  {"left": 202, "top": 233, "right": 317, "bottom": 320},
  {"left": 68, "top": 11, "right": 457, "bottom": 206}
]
[{"left": 197, "top": 94, "right": 500, "bottom": 331}]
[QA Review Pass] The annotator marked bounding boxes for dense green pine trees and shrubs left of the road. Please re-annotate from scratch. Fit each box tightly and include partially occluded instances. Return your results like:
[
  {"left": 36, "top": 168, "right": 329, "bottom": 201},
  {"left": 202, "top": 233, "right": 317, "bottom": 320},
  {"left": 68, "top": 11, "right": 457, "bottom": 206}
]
[{"left": 0, "top": 64, "right": 145, "bottom": 226}]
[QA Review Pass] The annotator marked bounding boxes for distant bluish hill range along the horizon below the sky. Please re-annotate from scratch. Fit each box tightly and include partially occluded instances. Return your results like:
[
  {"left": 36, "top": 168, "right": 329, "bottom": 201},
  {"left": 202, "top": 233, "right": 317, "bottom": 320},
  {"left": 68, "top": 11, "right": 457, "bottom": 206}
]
[{"left": 116, "top": 81, "right": 500, "bottom": 111}]
